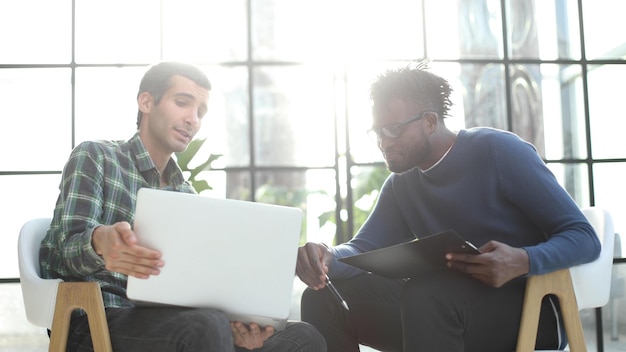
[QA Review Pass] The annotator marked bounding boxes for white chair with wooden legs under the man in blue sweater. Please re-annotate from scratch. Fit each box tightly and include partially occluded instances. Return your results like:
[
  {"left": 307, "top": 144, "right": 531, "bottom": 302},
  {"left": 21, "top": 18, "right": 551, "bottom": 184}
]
[{"left": 516, "top": 207, "right": 615, "bottom": 352}]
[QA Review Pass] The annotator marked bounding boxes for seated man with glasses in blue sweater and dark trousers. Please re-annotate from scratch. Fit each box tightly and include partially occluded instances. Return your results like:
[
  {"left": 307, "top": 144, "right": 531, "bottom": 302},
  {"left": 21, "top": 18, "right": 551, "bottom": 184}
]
[{"left": 297, "top": 65, "right": 600, "bottom": 352}]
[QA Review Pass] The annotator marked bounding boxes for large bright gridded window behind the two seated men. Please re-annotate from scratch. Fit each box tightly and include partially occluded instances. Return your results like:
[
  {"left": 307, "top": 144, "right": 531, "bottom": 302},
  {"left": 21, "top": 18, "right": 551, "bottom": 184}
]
[{"left": 0, "top": 0, "right": 626, "bottom": 348}]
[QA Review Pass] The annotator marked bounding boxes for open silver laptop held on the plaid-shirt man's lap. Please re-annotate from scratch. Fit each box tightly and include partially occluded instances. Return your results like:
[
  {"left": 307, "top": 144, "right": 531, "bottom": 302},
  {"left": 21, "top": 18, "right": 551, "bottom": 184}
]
[{"left": 127, "top": 188, "right": 302, "bottom": 330}]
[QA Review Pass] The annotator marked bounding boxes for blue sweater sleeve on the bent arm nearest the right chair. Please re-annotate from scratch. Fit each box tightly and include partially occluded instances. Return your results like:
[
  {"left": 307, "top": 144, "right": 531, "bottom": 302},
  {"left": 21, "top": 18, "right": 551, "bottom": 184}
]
[{"left": 492, "top": 134, "right": 600, "bottom": 275}]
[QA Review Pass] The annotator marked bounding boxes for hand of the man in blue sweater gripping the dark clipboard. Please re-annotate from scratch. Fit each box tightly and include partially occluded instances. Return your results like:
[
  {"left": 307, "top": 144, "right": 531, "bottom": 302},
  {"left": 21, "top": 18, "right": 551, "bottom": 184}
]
[{"left": 446, "top": 241, "right": 530, "bottom": 287}]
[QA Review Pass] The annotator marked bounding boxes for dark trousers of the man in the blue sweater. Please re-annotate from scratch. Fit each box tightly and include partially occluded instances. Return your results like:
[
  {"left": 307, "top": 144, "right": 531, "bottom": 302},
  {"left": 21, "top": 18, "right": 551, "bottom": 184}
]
[{"left": 301, "top": 269, "right": 558, "bottom": 352}]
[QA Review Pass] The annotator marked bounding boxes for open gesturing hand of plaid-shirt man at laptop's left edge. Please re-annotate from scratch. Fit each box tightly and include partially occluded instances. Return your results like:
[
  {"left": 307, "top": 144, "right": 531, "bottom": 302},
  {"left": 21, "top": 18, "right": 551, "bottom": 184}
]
[{"left": 91, "top": 221, "right": 163, "bottom": 279}]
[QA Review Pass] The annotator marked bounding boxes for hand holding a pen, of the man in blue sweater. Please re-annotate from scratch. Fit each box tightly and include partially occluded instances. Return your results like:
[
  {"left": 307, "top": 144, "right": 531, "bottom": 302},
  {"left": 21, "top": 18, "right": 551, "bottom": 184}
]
[{"left": 296, "top": 242, "right": 333, "bottom": 290}]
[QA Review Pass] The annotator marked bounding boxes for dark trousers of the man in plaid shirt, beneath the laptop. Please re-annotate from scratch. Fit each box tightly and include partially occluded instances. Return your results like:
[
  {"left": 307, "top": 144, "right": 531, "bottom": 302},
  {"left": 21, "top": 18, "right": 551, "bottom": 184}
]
[{"left": 67, "top": 308, "right": 326, "bottom": 352}]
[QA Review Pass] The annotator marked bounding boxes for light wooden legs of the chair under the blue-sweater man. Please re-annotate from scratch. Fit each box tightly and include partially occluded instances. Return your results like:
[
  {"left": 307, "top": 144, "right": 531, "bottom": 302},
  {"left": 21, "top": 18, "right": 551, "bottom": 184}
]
[{"left": 516, "top": 269, "right": 587, "bottom": 352}]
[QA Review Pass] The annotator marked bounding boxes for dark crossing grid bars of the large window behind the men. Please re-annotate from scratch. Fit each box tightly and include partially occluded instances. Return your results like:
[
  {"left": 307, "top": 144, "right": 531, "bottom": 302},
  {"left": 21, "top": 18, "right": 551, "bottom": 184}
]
[{"left": 0, "top": 0, "right": 626, "bottom": 266}]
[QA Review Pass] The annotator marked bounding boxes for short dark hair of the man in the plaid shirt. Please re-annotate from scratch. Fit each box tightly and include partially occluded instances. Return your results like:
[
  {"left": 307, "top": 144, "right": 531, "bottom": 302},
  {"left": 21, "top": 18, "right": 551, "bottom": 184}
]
[{"left": 137, "top": 62, "right": 211, "bottom": 128}]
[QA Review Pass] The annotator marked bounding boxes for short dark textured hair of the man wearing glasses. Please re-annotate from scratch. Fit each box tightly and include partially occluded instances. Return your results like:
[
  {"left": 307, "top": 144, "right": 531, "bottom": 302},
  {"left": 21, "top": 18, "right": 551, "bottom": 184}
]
[{"left": 370, "top": 61, "right": 452, "bottom": 118}]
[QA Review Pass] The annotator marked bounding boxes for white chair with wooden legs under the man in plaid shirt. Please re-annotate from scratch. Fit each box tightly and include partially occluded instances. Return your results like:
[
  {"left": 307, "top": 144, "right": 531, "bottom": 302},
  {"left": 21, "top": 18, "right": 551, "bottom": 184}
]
[{"left": 18, "top": 218, "right": 112, "bottom": 352}]
